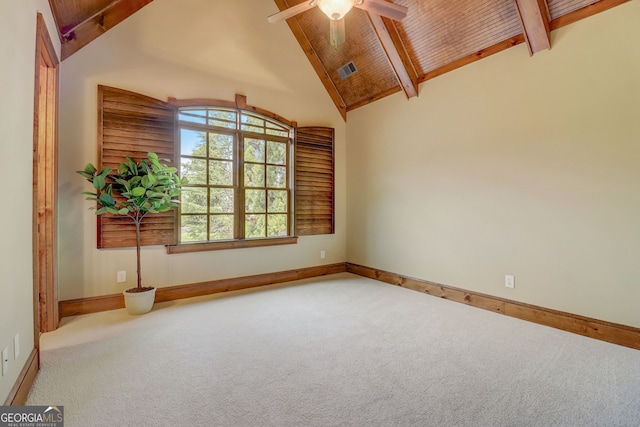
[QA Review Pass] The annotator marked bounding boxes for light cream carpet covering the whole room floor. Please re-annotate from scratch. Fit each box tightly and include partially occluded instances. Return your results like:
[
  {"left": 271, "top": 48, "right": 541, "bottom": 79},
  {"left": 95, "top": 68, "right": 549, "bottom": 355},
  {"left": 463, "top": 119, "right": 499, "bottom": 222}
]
[{"left": 27, "top": 273, "right": 640, "bottom": 427}]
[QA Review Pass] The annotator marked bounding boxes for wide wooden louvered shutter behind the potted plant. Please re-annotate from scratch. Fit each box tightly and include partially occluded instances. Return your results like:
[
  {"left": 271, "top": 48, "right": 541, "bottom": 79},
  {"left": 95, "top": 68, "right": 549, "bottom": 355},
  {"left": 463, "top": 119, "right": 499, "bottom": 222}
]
[{"left": 97, "top": 86, "right": 178, "bottom": 248}]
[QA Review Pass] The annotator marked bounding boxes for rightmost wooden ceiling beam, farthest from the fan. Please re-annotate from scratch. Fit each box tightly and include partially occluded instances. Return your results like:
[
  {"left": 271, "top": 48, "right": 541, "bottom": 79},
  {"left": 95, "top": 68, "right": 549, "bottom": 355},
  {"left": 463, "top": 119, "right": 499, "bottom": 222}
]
[{"left": 514, "top": 0, "right": 551, "bottom": 55}]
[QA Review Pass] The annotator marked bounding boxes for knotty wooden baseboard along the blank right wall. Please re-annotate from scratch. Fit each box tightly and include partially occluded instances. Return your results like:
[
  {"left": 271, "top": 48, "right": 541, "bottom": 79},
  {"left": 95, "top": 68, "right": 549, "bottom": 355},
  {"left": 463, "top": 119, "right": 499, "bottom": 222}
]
[{"left": 347, "top": 263, "right": 640, "bottom": 350}]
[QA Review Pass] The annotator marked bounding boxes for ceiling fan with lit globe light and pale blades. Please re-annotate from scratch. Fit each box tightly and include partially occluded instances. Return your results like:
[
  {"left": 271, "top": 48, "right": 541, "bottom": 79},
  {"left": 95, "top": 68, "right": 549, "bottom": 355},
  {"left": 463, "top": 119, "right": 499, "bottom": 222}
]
[{"left": 267, "top": 0, "right": 409, "bottom": 46}]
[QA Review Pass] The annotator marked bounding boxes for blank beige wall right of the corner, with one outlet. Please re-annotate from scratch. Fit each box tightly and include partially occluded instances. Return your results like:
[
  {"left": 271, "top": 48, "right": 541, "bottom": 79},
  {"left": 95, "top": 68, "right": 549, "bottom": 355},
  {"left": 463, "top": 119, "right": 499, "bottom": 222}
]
[{"left": 347, "top": 1, "right": 640, "bottom": 327}]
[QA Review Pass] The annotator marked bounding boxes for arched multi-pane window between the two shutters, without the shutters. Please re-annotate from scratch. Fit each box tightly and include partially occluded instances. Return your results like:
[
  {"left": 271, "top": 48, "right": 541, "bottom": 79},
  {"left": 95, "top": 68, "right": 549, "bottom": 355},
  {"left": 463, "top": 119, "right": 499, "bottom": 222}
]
[{"left": 178, "top": 107, "right": 293, "bottom": 243}]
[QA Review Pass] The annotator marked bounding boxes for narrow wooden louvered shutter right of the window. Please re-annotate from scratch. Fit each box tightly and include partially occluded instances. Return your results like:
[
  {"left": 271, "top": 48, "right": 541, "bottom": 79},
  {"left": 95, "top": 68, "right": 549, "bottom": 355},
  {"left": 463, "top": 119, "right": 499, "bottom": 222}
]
[{"left": 294, "top": 127, "right": 335, "bottom": 236}]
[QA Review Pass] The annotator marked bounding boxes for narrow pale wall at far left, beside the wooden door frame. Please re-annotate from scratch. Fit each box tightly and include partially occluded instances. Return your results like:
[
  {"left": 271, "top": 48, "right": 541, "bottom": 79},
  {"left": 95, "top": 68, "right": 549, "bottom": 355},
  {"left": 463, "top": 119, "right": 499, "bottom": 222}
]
[{"left": 0, "top": 0, "right": 60, "bottom": 404}]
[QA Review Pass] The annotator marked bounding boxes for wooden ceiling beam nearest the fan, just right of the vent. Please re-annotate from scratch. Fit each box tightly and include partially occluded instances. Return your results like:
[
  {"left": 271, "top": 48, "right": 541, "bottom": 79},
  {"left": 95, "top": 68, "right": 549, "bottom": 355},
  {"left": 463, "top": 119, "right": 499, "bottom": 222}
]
[{"left": 367, "top": 12, "right": 418, "bottom": 98}]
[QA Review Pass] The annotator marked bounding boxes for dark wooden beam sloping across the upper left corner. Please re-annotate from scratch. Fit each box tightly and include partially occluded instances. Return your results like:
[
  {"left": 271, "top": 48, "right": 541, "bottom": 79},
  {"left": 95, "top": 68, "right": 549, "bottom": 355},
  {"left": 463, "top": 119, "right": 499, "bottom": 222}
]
[{"left": 58, "top": 0, "right": 153, "bottom": 60}]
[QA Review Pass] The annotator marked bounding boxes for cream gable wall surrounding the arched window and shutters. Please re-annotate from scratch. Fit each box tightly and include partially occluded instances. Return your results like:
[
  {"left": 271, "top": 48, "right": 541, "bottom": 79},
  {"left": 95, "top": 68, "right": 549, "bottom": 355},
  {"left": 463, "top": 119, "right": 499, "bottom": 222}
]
[{"left": 58, "top": 0, "right": 346, "bottom": 300}]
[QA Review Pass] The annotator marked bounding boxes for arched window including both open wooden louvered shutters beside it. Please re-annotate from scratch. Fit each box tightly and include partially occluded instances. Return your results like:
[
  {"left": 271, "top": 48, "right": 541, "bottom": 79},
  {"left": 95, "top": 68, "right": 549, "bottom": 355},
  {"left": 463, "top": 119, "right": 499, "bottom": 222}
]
[{"left": 97, "top": 85, "right": 335, "bottom": 254}]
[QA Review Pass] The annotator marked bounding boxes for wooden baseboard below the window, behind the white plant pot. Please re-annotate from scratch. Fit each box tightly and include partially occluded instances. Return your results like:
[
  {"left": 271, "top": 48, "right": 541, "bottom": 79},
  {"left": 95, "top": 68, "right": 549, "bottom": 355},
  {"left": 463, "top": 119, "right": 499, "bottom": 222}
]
[{"left": 58, "top": 263, "right": 347, "bottom": 318}]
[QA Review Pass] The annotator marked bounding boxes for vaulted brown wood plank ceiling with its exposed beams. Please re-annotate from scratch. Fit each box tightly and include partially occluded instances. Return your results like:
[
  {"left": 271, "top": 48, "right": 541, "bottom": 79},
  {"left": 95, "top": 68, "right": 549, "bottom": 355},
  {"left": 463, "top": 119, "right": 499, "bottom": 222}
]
[{"left": 49, "top": 0, "right": 629, "bottom": 119}]
